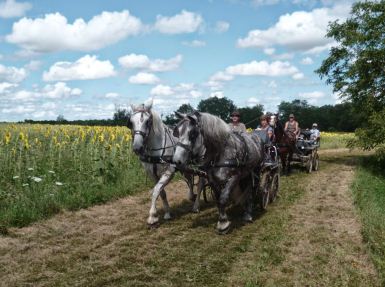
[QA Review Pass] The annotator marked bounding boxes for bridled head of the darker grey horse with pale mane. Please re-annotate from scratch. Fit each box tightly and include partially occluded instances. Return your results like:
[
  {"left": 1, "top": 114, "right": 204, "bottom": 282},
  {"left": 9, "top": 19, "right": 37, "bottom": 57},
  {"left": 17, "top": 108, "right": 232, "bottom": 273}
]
[{"left": 173, "top": 111, "right": 205, "bottom": 165}]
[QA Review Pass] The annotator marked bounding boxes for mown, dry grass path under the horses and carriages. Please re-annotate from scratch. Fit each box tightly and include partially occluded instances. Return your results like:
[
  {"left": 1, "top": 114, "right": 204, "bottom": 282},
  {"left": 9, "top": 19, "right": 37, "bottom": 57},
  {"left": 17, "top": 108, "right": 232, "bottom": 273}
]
[{"left": 0, "top": 151, "right": 378, "bottom": 286}]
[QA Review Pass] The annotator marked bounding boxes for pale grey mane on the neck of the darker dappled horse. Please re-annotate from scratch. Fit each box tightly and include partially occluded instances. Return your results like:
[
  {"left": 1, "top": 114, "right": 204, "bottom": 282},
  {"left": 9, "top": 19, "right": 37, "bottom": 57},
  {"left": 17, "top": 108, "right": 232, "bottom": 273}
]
[{"left": 199, "top": 113, "right": 231, "bottom": 149}]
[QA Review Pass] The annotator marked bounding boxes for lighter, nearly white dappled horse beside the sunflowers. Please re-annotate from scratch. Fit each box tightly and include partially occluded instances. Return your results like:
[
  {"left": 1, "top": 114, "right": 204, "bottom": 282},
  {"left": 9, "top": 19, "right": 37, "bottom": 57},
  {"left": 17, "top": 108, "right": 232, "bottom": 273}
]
[{"left": 127, "top": 101, "right": 199, "bottom": 225}]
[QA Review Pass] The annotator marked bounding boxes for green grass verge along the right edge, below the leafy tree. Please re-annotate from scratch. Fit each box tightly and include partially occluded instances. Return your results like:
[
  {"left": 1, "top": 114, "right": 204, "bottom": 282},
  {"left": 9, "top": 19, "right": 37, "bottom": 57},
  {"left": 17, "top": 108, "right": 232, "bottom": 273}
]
[{"left": 352, "top": 157, "right": 385, "bottom": 286}]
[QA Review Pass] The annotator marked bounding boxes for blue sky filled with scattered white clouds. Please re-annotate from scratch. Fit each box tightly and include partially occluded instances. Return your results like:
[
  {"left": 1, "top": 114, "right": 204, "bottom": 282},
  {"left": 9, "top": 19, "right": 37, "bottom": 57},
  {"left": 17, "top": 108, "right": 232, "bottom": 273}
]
[{"left": 0, "top": 0, "right": 351, "bottom": 121}]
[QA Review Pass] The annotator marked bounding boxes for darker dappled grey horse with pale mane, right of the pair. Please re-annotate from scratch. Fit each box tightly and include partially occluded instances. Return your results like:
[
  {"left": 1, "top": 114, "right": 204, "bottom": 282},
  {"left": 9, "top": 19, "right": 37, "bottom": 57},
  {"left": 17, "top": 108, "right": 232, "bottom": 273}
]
[{"left": 173, "top": 112, "right": 264, "bottom": 233}]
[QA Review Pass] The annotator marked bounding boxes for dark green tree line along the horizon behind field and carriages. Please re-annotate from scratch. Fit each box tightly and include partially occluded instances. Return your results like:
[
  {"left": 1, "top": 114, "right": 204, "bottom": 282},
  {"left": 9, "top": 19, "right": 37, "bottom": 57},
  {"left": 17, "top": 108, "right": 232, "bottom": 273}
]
[{"left": 24, "top": 97, "right": 364, "bottom": 132}]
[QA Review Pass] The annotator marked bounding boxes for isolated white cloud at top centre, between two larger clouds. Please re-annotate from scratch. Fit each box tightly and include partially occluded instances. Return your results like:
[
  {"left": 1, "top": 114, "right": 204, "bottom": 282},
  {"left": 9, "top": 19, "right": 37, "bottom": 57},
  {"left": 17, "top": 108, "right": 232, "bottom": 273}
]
[{"left": 154, "top": 10, "right": 203, "bottom": 34}]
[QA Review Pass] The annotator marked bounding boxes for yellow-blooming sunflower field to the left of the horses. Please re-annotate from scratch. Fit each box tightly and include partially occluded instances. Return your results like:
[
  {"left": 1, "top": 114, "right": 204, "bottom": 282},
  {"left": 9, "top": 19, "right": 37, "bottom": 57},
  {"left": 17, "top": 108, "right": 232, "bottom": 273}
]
[{"left": 0, "top": 124, "right": 150, "bottom": 231}]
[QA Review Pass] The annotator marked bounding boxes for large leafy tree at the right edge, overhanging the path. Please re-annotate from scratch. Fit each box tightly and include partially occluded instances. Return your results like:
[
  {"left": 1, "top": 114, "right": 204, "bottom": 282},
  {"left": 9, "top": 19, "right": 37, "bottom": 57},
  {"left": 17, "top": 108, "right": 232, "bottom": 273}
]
[{"left": 316, "top": 0, "right": 385, "bottom": 158}]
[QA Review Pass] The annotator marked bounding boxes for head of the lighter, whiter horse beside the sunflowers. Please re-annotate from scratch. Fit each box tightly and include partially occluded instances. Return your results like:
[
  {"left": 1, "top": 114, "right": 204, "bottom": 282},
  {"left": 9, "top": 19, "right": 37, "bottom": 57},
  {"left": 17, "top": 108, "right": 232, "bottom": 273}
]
[{"left": 127, "top": 101, "right": 153, "bottom": 154}]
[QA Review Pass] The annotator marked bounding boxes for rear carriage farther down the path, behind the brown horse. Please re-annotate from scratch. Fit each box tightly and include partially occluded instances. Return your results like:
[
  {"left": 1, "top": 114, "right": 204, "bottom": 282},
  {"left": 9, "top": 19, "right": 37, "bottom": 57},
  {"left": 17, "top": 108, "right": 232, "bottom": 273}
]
[{"left": 293, "top": 131, "right": 320, "bottom": 173}]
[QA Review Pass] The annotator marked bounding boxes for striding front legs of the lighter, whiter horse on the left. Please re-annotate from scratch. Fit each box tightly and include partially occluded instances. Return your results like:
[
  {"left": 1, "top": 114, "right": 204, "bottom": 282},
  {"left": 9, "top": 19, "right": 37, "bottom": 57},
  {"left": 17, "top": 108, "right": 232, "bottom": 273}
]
[{"left": 147, "top": 169, "right": 175, "bottom": 225}]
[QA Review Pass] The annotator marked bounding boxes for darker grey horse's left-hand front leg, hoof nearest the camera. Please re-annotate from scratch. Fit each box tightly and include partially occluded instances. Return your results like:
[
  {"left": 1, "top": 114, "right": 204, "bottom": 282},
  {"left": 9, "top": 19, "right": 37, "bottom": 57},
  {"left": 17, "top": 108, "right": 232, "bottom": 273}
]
[{"left": 217, "top": 175, "right": 240, "bottom": 233}]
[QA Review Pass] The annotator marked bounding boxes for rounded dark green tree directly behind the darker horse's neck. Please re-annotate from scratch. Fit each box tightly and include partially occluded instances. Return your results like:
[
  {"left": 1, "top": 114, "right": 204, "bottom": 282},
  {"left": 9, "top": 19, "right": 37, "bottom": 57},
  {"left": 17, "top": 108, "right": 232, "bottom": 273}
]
[{"left": 198, "top": 97, "right": 237, "bottom": 122}]
